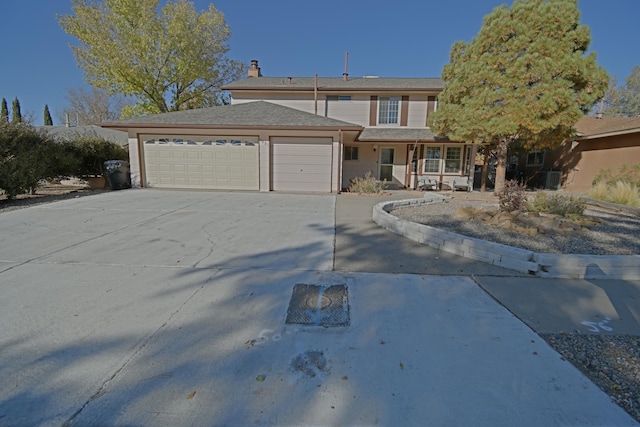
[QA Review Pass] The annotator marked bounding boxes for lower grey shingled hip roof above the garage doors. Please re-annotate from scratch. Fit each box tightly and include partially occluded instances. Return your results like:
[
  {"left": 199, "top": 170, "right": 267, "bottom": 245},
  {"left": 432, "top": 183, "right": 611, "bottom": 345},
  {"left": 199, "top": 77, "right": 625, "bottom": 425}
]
[{"left": 100, "top": 101, "right": 362, "bottom": 131}]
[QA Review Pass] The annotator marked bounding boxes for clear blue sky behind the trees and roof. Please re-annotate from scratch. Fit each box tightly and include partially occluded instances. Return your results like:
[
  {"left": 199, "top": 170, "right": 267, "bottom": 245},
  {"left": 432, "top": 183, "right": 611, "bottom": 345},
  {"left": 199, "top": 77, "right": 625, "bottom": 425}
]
[{"left": 0, "top": 0, "right": 640, "bottom": 125}]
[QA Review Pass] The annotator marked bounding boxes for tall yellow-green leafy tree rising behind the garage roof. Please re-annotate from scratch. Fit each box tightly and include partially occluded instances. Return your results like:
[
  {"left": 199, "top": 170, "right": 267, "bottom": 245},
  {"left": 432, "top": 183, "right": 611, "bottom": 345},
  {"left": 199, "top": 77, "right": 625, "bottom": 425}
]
[{"left": 59, "top": 0, "right": 246, "bottom": 115}]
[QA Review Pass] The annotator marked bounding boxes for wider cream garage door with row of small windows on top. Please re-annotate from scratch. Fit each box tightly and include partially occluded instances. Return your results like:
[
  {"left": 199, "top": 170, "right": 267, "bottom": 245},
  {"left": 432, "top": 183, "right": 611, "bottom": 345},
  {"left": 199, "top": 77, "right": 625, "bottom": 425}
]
[{"left": 142, "top": 136, "right": 260, "bottom": 190}]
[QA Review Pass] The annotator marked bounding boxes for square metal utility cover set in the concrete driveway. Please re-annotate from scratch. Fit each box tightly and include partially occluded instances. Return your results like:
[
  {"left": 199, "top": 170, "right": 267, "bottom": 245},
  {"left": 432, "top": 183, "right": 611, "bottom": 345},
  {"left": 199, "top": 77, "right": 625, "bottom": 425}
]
[{"left": 285, "top": 283, "right": 349, "bottom": 328}]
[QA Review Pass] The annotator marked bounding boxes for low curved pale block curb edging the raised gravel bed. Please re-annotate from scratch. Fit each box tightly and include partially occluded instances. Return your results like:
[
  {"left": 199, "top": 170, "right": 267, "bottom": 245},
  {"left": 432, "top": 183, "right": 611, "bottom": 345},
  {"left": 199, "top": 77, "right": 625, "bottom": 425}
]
[{"left": 373, "top": 193, "right": 640, "bottom": 280}]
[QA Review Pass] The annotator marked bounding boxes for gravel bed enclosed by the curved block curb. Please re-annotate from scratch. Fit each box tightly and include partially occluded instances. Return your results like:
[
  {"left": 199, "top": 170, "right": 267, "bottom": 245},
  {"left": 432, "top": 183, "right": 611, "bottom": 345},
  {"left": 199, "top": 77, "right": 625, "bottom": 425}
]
[{"left": 392, "top": 199, "right": 640, "bottom": 255}]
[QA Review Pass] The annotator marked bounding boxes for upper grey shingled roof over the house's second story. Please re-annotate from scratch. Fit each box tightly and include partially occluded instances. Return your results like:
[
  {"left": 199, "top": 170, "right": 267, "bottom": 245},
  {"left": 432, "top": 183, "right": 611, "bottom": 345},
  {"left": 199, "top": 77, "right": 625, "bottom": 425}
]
[{"left": 222, "top": 77, "right": 444, "bottom": 92}]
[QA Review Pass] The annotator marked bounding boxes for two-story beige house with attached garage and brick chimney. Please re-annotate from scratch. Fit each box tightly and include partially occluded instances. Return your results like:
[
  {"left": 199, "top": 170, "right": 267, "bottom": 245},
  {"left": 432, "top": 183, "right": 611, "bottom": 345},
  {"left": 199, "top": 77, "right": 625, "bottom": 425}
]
[{"left": 102, "top": 61, "right": 475, "bottom": 192}]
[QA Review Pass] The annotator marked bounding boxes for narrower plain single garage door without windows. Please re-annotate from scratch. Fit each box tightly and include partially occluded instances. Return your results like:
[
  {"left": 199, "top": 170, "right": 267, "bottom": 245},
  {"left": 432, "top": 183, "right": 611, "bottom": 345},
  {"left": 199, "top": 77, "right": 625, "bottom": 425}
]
[{"left": 271, "top": 137, "right": 333, "bottom": 192}]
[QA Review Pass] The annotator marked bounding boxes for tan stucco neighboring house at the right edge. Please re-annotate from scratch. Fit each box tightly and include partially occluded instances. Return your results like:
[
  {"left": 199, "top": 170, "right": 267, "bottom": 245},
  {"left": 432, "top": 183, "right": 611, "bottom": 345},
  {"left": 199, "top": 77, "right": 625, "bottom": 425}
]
[{"left": 510, "top": 116, "right": 640, "bottom": 191}]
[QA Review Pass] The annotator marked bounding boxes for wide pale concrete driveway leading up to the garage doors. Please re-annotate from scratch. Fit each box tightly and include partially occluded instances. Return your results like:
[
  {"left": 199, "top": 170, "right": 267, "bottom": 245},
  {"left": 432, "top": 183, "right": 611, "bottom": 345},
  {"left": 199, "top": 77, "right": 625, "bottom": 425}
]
[{"left": 0, "top": 190, "right": 636, "bottom": 426}]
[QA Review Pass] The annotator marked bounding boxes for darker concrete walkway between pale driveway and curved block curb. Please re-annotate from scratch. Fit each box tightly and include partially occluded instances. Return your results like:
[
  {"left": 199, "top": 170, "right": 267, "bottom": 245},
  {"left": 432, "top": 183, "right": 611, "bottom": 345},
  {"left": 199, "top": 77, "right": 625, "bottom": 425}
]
[{"left": 335, "top": 191, "right": 640, "bottom": 336}]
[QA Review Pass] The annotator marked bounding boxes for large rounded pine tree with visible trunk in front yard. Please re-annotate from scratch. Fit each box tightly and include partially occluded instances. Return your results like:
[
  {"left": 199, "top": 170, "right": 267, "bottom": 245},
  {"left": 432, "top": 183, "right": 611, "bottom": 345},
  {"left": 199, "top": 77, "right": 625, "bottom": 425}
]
[{"left": 430, "top": 0, "right": 609, "bottom": 192}]
